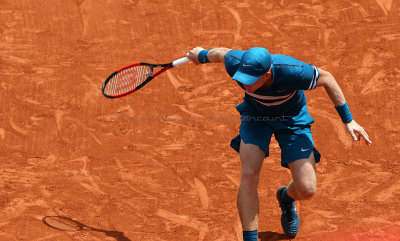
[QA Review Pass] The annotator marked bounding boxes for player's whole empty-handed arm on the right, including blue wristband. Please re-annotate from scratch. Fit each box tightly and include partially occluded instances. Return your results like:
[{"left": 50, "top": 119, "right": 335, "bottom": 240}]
[{"left": 317, "top": 68, "right": 372, "bottom": 146}]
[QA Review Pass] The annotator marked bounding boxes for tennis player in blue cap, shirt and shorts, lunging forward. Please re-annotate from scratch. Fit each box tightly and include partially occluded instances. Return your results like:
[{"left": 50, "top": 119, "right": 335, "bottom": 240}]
[{"left": 187, "top": 47, "right": 372, "bottom": 241}]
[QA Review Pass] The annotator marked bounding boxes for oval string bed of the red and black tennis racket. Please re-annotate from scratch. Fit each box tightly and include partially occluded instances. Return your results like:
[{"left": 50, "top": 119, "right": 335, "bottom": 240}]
[{"left": 104, "top": 65, "right": 152, "bottom": 96}]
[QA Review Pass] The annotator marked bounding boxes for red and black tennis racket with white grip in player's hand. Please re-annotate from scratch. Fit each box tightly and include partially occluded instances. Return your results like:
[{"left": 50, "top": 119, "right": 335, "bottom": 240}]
[{"left": 101, "top": 57, "right": 190, "bottom": 98}]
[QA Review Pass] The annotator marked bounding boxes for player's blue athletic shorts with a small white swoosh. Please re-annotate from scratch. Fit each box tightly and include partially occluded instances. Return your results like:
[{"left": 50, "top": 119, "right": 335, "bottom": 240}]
[{"left": 231, "top": 104, "right": 321, "bottom": 168}]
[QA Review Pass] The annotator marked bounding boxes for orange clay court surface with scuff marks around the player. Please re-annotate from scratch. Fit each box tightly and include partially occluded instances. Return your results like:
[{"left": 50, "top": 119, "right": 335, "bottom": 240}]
[{"left": 0, "top": 0, "right": 400, "bottom": 241}]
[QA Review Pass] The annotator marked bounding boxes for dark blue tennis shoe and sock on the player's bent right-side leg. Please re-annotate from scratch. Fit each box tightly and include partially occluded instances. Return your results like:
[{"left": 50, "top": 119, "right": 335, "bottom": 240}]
[{"left": 276, "top": 187, "right": 300, "bottom": 238}]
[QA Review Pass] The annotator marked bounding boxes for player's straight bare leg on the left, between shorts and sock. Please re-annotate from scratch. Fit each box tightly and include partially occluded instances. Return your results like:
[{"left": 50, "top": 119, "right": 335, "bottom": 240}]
[{"left": 237, "top": 140, "right": 265, "bottom": 231}]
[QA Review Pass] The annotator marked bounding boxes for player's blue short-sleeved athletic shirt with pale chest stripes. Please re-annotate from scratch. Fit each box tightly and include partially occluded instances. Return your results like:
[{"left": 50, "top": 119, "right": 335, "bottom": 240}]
[{"left": 224, "top": 50, "right": 319, "bottom": 125}]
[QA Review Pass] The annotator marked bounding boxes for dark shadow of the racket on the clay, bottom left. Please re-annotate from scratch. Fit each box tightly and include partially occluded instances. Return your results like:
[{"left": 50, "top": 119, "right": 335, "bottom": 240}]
[{"left": 42, "top": 216, "right": 132, "bottom": 241}]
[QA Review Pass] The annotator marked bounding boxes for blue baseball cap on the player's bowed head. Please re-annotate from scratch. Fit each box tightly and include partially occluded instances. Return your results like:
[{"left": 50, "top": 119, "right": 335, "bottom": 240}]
[{"left": 232, "top": 47, "right": 271, "bottom": 85}]
